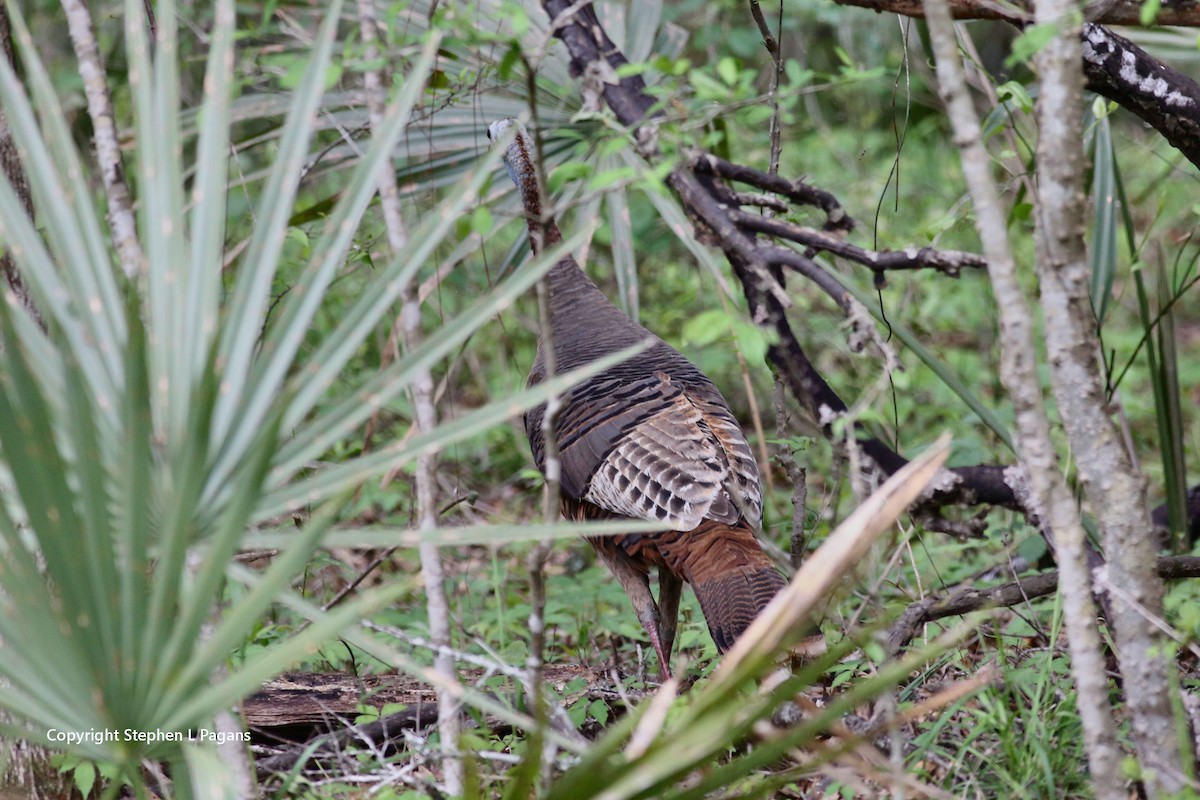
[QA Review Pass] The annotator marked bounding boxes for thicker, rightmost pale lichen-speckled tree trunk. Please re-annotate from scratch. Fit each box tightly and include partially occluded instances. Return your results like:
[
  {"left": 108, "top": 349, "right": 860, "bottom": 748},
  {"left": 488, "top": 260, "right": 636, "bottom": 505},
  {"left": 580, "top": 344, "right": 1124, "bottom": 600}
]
[{"left": 1034, "top": 0, "right": 1183, "bottom": 796}]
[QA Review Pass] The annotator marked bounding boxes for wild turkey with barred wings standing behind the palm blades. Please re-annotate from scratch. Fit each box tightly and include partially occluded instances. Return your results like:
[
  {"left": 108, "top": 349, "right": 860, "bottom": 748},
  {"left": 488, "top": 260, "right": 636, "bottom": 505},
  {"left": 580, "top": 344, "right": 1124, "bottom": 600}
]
[{"left": 488, "top": 120, "right": 785, "bottom": 675}]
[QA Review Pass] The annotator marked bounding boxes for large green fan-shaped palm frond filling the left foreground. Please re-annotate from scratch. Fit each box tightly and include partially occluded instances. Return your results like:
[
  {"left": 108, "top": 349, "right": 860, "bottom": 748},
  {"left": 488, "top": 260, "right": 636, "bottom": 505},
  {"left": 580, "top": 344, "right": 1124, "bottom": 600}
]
[{"left": 0, "top": 0, "right": 619, "bottom": 790}]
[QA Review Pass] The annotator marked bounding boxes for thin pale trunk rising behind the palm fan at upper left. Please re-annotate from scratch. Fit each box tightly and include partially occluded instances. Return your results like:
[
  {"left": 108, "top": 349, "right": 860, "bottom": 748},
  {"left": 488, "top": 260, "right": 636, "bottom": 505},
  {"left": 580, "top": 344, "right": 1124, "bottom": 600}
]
[{"left": 62, "top": 0, "right": 142, "bottom": 279}]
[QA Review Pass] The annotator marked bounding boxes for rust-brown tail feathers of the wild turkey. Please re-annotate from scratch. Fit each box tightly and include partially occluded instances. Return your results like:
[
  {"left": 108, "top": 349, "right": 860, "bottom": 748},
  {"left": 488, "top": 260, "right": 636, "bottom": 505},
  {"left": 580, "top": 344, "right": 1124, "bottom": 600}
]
[{"left": 659, "top": 519, "right": 787, "bottom": 652}]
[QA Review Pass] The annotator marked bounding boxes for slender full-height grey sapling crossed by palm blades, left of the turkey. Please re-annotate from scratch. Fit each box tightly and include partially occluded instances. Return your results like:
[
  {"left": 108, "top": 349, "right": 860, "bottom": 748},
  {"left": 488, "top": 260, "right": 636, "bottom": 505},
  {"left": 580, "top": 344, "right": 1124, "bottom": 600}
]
[{"left": 358, "top": 0, "right": 463, "bottom": 795}]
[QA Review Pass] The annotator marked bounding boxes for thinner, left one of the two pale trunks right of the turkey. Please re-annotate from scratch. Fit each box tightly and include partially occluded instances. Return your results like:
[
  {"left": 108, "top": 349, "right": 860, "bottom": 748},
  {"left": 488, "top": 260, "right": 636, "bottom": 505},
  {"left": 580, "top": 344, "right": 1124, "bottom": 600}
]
[{"left": 925, "top": 0, "right": 1123, "bottom": 800}]
